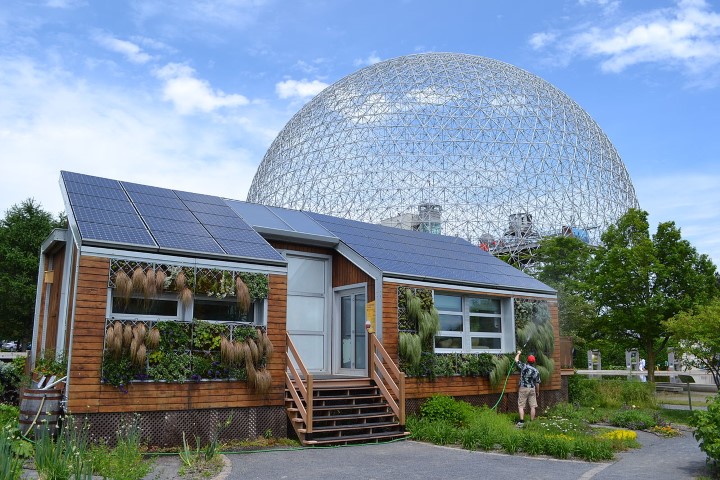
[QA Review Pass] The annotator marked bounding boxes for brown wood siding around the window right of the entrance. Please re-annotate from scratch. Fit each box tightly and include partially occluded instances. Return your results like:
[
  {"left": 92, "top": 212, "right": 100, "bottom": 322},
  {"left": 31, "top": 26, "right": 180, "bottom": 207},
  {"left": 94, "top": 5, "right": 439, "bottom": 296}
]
[{"left": 382, "top": 282, "right": 561, "bottom": 399}]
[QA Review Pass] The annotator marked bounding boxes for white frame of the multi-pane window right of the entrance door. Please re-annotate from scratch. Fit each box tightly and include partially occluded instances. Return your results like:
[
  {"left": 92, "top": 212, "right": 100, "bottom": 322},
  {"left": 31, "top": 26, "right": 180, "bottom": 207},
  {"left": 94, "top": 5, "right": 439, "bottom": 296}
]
[{"left": 433, "top": 290, "right": 515, "bottom": 353}]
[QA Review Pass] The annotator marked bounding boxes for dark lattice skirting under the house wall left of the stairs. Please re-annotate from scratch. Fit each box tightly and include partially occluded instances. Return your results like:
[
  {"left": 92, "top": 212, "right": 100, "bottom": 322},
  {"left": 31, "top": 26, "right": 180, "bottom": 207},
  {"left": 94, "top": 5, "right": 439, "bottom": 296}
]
[{"left": 83, "top": 407, "right": 287, "bottom": 447}]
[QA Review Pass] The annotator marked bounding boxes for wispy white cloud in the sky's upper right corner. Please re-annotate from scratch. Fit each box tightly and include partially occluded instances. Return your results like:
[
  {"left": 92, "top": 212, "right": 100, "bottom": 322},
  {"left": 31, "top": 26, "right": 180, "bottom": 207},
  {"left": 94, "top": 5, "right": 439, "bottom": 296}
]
[{"left": 530, "top": 0, "right": 720, "bottom": 79}]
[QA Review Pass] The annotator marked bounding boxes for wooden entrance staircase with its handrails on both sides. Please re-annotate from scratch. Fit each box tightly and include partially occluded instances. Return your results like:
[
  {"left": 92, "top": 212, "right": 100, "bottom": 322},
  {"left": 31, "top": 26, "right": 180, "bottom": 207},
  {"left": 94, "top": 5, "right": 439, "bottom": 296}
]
[{"left": 285, "top": 335, "right": 409, "bottom": 446}]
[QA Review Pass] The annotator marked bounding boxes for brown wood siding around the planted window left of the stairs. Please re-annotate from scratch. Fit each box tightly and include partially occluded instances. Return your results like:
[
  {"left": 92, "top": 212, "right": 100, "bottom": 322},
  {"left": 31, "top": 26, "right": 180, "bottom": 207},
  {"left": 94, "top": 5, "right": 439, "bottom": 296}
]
[{"left": 67, "top": 256, "right": 287, "bottom": 414}]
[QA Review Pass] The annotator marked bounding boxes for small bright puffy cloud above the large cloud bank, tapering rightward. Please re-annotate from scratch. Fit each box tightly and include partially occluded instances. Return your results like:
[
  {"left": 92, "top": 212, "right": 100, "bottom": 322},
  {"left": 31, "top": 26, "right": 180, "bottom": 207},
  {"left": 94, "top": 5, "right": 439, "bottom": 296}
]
[{"left": 154, "top": 63, "right": 250, "bottom": 115}]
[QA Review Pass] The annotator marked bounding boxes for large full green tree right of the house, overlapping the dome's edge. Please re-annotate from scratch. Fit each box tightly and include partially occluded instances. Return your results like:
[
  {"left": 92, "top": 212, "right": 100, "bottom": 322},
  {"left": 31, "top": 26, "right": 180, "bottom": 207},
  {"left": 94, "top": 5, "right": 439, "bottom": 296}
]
[{"left": 586, "top": 209, "right": 717, "bottom": 381}]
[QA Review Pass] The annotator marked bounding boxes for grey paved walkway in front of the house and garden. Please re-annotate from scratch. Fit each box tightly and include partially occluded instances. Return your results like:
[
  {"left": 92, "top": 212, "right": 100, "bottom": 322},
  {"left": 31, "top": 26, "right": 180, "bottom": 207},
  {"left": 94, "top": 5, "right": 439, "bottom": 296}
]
[{"left": 141, "top": 432, "right": 706, "bottom": 480}]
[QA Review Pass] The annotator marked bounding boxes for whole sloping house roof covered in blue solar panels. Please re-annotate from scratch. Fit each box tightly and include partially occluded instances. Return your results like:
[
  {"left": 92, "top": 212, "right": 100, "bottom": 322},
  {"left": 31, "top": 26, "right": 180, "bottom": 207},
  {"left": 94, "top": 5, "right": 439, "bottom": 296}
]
[{"left": 60, "top": 171, "right": 554, "bottom": 293}]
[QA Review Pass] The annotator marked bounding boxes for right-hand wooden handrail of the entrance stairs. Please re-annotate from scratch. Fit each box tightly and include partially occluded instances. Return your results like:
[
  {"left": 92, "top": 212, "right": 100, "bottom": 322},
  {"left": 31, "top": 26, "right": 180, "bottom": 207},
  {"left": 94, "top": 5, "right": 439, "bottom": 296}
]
[{"left": 368, "top": 333, "right": 405, "bottom": 425}]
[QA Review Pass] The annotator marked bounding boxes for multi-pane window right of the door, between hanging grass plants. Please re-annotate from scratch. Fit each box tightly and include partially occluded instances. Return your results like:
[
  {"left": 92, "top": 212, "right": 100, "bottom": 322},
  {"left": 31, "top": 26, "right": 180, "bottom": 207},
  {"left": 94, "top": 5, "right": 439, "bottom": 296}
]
[{"left": 434, "top": 291, "right": 515, "bottom": 353}]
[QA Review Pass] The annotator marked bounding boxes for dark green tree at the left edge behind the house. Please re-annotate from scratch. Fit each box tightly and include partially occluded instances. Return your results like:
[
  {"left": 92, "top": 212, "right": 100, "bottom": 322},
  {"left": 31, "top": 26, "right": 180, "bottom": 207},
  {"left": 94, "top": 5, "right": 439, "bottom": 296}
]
[{"left": 0, "top": 198, "right": 65, "bottom": 341}]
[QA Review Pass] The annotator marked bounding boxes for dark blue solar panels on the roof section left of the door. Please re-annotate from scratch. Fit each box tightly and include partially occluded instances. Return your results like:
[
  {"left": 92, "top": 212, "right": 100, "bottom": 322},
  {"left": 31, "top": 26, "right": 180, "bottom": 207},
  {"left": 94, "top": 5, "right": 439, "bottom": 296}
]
[{"left": 61, "top": 172, "right": 284, "bottom": 261}]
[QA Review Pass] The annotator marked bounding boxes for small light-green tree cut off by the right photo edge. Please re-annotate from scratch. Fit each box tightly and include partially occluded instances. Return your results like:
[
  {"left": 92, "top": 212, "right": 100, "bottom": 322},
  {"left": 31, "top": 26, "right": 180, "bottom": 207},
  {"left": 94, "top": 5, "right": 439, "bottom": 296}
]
[{"left": 664, "top": 300, "right": 720, "bottom": 388}]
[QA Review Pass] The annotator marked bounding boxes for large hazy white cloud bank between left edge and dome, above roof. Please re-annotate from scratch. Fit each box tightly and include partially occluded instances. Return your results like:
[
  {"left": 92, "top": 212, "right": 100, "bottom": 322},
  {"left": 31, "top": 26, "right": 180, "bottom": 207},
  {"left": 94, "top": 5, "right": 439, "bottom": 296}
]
[{"left": 0, "top": 56, "right": 278, "bottom": 218}]
